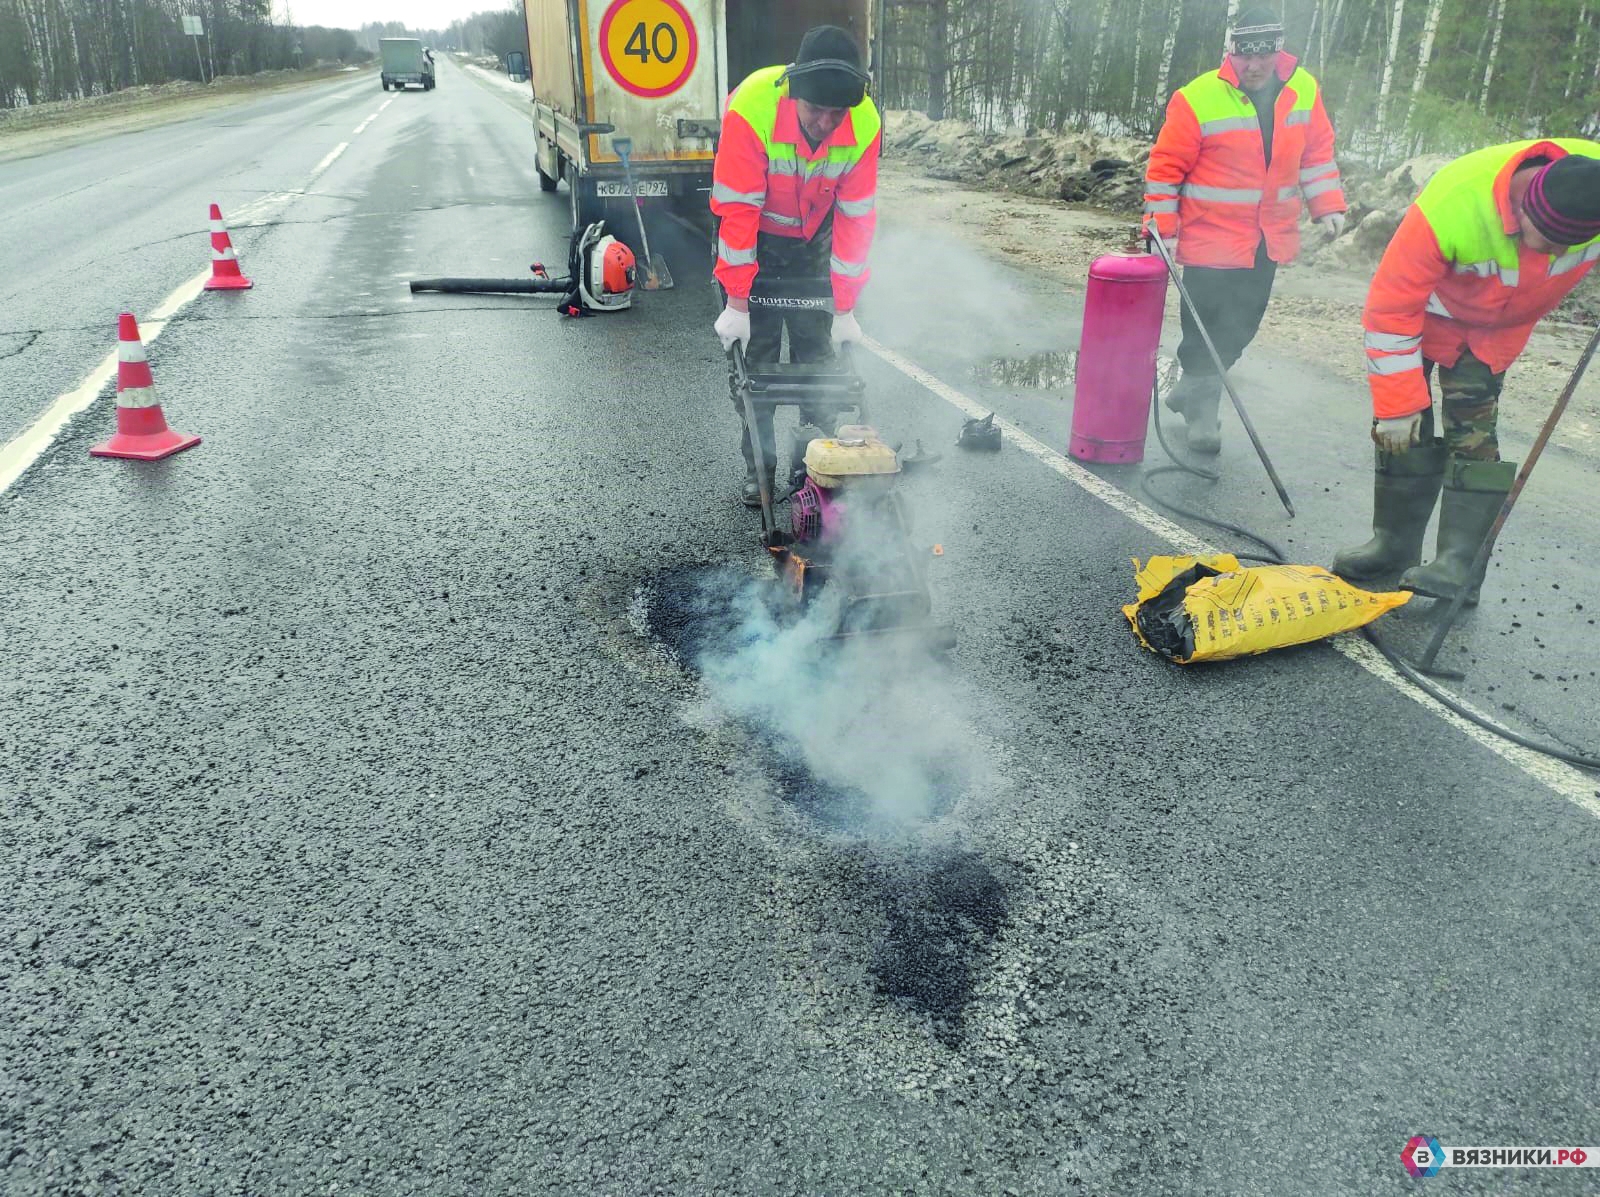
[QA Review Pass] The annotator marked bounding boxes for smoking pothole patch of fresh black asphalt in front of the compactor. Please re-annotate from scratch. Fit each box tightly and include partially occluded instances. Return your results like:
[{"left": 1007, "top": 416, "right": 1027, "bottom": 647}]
[{"left": 632, "top": 566, "right": 1008, "bottom": 1047}]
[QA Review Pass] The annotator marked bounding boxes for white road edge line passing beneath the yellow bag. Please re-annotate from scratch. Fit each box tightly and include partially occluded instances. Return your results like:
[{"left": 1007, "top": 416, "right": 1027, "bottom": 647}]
[{"left": 862, "top": 338, "right": 1600, "bottom": 818}]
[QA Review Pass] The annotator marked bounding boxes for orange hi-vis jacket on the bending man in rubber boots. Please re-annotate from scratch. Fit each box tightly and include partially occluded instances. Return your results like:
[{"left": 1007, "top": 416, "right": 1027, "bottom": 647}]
[{"left": 1362, "top": 138, "right": 1600, "bottom": 419}]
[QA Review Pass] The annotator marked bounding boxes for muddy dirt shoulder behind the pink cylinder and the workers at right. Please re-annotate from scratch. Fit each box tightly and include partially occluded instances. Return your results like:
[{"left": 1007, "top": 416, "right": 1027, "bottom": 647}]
[{"left": 878, "top": 160, "right": 1600, "bottom": 459}]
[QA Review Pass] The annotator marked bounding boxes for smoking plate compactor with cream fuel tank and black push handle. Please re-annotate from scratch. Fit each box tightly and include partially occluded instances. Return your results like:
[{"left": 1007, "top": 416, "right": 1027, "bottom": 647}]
[{"left": 728, "top": 274, "right": 955, "bottom": 651}]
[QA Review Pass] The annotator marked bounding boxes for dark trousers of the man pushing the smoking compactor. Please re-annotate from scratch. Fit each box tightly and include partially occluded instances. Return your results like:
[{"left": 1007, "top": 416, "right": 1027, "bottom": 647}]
[{"left": 734, "top": 216, "right": 835, "bottom": 478}]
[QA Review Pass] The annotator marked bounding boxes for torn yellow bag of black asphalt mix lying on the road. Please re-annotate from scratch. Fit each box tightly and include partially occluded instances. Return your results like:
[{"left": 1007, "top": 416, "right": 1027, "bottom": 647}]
[{"left": 1122, "top": 552, "right": 1411, "bottom": 666}]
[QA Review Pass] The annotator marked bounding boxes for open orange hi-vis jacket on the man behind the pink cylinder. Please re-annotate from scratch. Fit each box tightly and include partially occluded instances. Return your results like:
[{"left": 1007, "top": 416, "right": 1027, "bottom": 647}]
[{"left": 1144, "top": 53, "right": 1346, "bottom": 269}]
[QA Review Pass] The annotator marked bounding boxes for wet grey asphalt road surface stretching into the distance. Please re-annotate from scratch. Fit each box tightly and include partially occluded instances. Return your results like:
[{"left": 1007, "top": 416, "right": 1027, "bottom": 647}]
[{"left": 0, "top": 56, "right": 1600, "bottom": 1195}]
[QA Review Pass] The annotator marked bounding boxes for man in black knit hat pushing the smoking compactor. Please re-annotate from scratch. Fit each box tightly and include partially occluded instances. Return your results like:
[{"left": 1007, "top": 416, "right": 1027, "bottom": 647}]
[{"left": 710, "top": 26, "right": 882, "bottom": 507}]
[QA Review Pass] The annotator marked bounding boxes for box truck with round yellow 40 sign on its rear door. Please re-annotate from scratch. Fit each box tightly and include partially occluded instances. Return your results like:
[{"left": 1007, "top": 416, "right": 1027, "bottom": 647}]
[{"left": 523, "top": 0, "right": 883, "bottom": 230}]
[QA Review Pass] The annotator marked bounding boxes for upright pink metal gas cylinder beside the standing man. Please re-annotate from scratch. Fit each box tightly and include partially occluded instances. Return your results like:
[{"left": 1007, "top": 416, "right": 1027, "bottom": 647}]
[{"left": 1067, "top": 253, "right": 1166, "bottom": 461}]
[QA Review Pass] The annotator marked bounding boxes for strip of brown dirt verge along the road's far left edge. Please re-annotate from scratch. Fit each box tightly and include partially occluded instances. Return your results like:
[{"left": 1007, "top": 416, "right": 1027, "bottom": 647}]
[{"left": 0, "top": 66, "right": 374, "bottom": 162}]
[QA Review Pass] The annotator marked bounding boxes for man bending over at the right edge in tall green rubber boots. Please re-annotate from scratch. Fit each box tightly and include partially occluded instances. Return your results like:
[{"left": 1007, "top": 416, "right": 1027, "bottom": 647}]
[{"left": 1333, "top": 138, "right": 1600, "bottom": 603}]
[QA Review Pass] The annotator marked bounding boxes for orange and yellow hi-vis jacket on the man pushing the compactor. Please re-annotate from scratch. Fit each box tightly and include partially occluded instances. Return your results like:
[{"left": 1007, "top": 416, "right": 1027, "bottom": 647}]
[{"left": 710, "top": 66, "right": 883, "bottom": 312}]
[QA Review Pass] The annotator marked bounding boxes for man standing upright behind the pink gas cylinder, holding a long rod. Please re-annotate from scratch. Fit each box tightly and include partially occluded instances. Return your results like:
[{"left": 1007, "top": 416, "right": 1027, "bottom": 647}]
[{"left": 1144, "top": 6, "right": 1346, "bottom": 453}]
